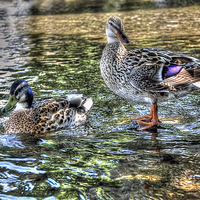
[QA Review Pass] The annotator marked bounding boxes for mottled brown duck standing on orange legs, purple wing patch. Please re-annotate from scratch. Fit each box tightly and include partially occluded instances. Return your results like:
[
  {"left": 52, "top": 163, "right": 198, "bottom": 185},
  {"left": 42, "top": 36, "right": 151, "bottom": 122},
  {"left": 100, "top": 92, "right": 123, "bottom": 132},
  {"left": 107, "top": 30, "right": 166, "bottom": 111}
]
[{"left": 100, "top": 16, "right": 200, "bottom": 130}]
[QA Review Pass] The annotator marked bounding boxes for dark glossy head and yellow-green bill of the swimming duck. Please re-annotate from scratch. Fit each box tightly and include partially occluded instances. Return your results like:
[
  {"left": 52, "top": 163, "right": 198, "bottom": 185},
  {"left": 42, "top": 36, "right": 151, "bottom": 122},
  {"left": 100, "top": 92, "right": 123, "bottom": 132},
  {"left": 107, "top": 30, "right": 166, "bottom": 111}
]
[{"left": 2, "top": 80, "right": 33, "bottom": 113}]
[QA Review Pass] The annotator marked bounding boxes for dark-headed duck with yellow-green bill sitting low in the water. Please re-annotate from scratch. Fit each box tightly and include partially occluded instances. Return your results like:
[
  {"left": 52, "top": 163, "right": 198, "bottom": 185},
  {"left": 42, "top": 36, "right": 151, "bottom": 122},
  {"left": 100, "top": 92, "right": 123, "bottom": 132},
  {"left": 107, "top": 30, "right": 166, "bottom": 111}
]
[{"left": 2, "top": 80, "right": 93, "bottom": 135}]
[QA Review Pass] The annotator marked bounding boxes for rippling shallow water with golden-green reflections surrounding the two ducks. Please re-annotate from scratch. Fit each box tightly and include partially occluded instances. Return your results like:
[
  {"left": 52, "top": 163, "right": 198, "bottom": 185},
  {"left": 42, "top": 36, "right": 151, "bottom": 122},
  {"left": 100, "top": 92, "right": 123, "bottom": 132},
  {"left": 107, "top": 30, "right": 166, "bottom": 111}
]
[{"left": 0, "top": 1, "right": 200, "bottom": 200}]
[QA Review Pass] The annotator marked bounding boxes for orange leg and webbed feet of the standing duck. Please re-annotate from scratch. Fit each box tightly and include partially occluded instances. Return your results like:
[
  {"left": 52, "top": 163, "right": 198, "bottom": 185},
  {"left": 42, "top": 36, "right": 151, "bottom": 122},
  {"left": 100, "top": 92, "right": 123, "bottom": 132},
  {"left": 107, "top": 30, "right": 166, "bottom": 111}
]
[{"left": 134, "top": 104, "right": 161, "bottom": 130}]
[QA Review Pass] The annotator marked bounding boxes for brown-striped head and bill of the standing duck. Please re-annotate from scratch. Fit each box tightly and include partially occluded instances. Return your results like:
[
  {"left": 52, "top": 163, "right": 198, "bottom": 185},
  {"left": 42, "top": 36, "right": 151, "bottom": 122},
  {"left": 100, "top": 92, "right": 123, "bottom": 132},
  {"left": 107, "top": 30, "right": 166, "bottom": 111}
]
[{"left": 106, "top": 16, "right": 130, "bottom": 43}]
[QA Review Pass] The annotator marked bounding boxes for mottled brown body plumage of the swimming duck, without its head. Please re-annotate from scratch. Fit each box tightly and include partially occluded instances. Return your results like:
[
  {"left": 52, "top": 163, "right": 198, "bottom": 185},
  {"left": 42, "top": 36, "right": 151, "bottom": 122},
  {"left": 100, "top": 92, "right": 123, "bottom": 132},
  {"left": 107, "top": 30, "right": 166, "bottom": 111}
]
[{"left": 5, "top": 94, "right": 92, "bottom": 135}]
